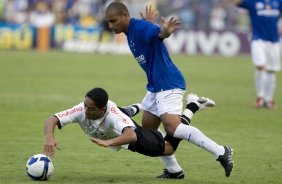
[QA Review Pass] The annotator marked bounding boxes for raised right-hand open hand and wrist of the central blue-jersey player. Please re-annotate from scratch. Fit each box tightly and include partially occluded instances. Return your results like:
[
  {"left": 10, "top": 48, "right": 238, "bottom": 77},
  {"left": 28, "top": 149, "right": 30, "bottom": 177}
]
[{"left": 159, "top": 17, "right": 181, "bottom": 39}]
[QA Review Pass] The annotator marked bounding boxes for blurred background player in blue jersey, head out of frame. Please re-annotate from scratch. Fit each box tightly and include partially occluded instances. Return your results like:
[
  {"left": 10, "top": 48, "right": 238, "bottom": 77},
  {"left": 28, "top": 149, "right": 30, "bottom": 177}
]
[{"left": 227, "top": 0, "right": 282, "bottom": 109}]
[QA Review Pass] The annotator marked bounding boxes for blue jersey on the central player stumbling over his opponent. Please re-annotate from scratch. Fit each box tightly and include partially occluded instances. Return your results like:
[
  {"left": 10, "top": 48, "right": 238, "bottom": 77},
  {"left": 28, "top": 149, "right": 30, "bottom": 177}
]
[{"left": 126, "top": 18, "right": 186, "bottom": 93}]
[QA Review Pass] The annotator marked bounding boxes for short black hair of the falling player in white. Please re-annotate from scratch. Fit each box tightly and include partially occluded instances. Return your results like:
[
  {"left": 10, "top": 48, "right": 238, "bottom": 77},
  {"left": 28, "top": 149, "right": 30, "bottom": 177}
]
[{"left": 85, "top": 87, "right": 109, "bottom": 109}]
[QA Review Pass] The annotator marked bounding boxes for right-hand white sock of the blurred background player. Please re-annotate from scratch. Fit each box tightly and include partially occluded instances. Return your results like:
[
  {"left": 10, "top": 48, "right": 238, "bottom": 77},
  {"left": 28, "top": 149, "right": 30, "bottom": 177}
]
[{"left": 265, "top": 72, "right": 276, "bottom": 102}]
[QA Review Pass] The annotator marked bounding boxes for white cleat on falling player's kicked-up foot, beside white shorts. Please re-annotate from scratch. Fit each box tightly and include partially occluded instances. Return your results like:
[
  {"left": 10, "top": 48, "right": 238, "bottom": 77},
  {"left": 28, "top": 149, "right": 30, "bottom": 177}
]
[{"left": 186, "top": 93, "right": 215, "bottom": 111}]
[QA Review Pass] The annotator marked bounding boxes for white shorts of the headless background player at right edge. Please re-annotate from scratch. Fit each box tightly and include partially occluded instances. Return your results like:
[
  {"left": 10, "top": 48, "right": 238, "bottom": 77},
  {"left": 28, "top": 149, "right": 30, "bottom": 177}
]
[{"left": 251, "top": 40, "right": 281, "bottom": 71}]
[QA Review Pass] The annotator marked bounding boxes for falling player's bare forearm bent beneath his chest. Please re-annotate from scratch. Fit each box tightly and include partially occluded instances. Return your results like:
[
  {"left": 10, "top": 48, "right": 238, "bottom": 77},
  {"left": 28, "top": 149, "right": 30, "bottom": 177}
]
[{"left": 90, "top": 127, "right": 137, "bottom": 147}]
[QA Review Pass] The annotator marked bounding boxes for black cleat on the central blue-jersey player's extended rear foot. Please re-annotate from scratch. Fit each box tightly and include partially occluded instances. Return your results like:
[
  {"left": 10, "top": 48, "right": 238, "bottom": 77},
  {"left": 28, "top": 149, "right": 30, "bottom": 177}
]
[{"left": 217, "top": 146, "right": 234, "bottom": 177}]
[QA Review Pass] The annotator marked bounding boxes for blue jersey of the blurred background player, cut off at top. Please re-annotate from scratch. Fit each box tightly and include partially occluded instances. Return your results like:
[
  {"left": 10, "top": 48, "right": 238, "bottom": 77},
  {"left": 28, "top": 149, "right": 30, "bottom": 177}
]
[{"left": 238, "top": 0, "right": 282, "bottom": 42}]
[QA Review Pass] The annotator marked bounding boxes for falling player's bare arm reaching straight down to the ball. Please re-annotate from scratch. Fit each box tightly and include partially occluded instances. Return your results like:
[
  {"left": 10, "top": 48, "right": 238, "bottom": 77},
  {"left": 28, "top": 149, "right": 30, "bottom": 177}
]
[{"left": 43, "top": 116, "right": 60, "bottom": 157}]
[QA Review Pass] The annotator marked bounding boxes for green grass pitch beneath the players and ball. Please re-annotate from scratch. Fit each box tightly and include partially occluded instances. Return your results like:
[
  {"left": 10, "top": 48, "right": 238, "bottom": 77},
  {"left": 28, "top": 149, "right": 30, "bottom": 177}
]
[{"left": 0, "top": 51, "right": 282, "bottom": 184}]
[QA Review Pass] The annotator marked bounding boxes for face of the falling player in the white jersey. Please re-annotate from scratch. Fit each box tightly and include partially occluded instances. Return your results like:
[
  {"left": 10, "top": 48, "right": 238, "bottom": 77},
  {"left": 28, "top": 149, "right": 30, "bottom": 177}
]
[{"left": 84, "top": 97, "right": 106, "bottom": 120}]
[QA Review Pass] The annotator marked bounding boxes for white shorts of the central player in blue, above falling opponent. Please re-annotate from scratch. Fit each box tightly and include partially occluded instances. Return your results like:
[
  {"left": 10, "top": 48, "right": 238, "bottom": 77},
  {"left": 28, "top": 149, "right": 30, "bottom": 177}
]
[{"left": 142, "top": 89, "right": 185, "bottom": 117}]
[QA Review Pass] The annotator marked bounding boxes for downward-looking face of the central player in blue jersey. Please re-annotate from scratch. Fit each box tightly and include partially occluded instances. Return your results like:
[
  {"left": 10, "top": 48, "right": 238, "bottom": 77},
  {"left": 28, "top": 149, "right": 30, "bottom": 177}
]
[{"left": 106, "top": 10, "right": 128, "bottom": 34}]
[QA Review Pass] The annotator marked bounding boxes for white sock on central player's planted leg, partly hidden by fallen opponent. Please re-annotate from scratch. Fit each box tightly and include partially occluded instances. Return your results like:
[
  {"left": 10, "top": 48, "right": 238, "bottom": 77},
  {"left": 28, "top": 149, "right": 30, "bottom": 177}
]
[{"left": 158, "top": 128, "right": 182, "bottom": 173}]
